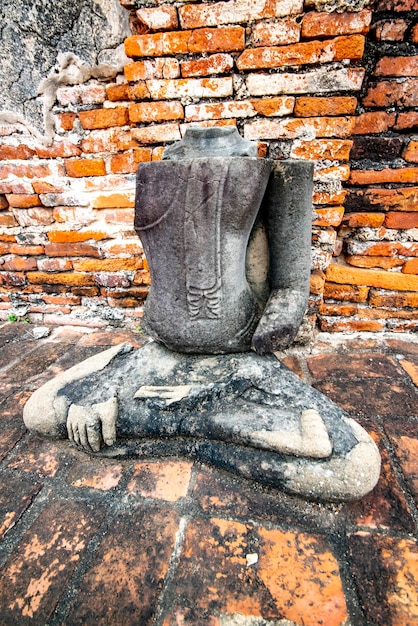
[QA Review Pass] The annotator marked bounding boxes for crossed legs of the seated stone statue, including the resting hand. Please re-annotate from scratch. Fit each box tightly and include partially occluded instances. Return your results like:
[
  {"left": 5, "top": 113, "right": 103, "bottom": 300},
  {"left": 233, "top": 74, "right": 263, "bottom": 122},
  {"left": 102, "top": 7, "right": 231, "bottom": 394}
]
[{"left": 24, "top": 343, "right": 380, "bottom": 501}]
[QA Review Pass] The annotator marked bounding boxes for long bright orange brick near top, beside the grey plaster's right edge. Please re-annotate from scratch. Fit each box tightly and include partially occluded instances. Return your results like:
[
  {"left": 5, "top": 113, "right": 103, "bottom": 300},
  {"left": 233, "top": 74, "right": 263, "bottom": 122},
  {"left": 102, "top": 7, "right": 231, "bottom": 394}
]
[{"left": 125, "top": 26, "right": 245, "bottom": 57}]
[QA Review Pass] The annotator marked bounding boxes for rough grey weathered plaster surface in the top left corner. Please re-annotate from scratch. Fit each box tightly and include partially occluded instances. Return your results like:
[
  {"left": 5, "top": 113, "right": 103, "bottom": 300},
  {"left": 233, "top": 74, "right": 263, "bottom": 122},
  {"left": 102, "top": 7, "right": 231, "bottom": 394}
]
[{"left": 0, "top": 0, "right": 129, "bottom": 129}]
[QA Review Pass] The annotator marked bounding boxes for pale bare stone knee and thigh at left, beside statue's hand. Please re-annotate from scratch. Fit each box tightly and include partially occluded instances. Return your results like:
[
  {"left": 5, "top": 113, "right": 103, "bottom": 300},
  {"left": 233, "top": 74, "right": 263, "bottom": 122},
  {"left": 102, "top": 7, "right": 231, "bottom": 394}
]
[{"left": 23, "top": 343, "right": 133, "bottom": 438}]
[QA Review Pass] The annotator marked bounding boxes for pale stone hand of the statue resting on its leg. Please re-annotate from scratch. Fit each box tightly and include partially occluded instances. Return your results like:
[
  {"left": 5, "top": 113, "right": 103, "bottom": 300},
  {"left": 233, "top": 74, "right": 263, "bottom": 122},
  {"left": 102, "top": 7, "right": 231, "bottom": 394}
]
[{"left": 67, "top": 398, "right": 118, "bottom": 452}]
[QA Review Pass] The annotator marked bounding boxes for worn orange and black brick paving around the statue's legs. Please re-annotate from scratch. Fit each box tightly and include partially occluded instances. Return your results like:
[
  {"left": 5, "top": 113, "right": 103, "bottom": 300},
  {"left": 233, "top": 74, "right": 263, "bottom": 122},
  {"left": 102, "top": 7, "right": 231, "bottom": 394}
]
[{"left": 0, "top": 323, "right": 418, "bottom": 626}]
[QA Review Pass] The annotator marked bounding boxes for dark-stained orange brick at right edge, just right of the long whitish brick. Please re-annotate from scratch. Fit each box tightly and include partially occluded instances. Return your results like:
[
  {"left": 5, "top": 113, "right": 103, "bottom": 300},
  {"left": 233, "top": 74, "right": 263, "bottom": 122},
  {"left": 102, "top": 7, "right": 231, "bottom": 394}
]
[{"left": 363, "top": 78, "right": 418, "bottom": 108}]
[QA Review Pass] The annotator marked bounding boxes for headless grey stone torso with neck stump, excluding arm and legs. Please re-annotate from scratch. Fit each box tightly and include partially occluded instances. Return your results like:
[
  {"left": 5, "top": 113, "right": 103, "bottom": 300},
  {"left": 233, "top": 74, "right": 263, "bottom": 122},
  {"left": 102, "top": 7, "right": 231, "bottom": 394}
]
[{"left": 135, "top": 129, "right": 272, "bottom": 353}]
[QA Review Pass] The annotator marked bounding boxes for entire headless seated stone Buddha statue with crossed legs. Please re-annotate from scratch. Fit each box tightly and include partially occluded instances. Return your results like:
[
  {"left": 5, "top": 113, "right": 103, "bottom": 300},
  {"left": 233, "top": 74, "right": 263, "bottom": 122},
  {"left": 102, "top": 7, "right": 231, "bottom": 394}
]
[{"left": 24, "top": 127, "right": 380, "bottom": 501}]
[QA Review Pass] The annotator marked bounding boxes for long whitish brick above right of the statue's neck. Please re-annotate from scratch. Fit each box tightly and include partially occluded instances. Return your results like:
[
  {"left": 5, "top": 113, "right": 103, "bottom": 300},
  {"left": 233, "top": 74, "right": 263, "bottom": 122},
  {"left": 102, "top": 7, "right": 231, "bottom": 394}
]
[{"left": 246, "top": 67, "right": 364, "bottom": 96}]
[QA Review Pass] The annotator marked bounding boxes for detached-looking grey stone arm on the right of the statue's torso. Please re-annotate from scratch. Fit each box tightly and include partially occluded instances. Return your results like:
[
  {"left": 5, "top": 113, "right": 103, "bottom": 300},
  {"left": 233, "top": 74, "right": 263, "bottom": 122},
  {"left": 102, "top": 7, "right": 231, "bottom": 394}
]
[{"left": 253, "top": 161, "right": 313, "bottom": 354}]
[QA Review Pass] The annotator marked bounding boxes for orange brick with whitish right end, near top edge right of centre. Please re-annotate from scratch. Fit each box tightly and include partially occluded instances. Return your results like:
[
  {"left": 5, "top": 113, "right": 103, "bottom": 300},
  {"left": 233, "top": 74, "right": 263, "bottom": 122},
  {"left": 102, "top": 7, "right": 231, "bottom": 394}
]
[{"left": 302, "top": 9, "right": 372, "bottom": 38}]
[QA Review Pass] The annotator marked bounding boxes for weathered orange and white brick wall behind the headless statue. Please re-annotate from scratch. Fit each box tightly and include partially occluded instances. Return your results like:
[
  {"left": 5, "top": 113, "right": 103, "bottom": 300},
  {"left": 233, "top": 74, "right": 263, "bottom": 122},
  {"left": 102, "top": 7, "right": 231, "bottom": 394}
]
[{"left": 0, "top": 0, "right": 418, "bottom": 331}]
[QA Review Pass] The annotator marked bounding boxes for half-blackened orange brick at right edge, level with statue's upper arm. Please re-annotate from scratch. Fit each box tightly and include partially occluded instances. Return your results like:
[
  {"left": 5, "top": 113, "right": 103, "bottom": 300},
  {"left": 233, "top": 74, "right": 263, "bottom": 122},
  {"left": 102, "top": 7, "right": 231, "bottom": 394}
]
[{"left": 346, "top": 187, "right": 418, "bottom": 211}]
